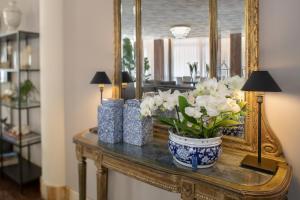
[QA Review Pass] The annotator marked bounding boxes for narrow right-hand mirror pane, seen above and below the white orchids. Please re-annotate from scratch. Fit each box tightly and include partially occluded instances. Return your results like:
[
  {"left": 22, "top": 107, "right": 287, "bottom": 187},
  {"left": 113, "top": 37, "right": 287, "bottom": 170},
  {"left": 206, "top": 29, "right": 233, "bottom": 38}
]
[{"left": 217, "top": 0, "right": 246, "bottom": 138}]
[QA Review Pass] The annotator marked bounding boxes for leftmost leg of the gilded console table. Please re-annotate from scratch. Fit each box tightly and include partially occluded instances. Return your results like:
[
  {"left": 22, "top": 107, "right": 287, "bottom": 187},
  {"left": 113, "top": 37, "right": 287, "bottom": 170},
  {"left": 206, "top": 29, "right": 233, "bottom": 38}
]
[{"left": 78, "top": 157, "right": 86, "bottom": 200}]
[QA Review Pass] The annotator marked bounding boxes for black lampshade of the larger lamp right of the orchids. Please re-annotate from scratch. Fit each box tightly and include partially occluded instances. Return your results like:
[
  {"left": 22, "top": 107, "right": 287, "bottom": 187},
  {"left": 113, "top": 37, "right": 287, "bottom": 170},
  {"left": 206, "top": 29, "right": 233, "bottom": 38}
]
[{"left": 242, "top": 71, "right": 281, "bottom": 92}]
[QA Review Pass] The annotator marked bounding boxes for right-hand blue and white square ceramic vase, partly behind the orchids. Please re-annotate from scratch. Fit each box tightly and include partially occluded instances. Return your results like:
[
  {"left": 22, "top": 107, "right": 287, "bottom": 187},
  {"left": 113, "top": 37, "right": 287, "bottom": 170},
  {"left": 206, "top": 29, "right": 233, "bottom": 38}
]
[{"left": 123, "top": 99, "right": 153, "bottom": 146}]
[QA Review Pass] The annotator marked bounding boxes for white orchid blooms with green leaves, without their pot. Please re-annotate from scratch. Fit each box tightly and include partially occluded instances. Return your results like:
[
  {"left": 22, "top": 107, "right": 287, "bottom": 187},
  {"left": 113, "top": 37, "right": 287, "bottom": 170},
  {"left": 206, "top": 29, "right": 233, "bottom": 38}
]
[{"left": 141, "top": 76, "right": 246, "bottom": 139}]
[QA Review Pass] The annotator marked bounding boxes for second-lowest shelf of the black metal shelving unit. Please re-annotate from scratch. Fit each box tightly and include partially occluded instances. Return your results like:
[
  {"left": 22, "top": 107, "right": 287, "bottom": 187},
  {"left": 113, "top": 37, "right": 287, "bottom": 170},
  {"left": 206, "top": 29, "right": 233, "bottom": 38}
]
[{"left": 0, "top": 132, "right": 41, "bottom": 147}]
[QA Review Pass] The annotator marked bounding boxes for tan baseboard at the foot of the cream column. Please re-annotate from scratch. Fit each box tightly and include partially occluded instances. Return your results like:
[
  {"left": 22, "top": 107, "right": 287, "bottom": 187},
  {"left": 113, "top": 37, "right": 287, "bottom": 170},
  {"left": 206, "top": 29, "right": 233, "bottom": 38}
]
[{"left": 40, "top": 179, "right": 70, "bottom": 200}]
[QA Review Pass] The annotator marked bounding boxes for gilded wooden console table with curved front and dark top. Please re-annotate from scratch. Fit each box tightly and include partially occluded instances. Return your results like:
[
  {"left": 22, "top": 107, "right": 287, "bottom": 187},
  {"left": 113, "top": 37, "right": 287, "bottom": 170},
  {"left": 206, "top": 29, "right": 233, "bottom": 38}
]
[{"left": 74, "top": 132, "right": 291, "bottom": 200}]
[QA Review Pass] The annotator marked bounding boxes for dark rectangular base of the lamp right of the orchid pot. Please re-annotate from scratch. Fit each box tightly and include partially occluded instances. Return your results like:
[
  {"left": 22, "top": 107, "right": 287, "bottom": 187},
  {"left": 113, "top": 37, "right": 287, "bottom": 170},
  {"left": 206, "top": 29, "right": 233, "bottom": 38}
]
[{"left": 241, "top": 155, "right": 277, "bottom": 175}]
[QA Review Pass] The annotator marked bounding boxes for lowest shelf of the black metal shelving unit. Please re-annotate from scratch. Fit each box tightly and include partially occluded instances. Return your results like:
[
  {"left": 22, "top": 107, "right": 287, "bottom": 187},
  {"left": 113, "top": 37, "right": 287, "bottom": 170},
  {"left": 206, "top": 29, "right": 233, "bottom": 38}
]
[{"left": 3, "top": 158, "right": 41, "bottom": 184}]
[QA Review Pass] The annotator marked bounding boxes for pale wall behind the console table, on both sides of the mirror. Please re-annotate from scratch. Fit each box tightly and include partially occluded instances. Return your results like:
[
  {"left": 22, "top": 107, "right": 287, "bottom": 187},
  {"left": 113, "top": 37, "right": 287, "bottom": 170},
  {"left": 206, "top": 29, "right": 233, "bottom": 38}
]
[{"left": 65, "top": 0, "right": 300, "bottom": 200}]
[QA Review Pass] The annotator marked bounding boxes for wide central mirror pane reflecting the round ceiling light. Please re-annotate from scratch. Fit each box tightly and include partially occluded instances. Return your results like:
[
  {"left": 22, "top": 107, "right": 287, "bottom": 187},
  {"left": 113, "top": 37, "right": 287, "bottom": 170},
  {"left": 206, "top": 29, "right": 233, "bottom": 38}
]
[{"left": 142, "top": 0, "right": 209, "bottom": 96}]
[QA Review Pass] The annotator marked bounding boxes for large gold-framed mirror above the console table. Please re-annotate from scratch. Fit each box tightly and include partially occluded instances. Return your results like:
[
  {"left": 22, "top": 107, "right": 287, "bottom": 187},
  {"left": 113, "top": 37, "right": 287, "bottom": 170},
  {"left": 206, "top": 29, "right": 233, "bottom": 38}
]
[{"left": 113, "top": 0, "right": 282, "bottom": 157}]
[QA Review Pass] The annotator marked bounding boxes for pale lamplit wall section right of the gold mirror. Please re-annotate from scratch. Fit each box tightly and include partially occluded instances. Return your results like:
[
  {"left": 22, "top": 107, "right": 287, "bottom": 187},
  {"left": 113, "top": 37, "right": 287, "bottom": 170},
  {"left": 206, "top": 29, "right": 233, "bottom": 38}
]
[{"left": 260, "top": 0, "right": 300, "bottom": 200}]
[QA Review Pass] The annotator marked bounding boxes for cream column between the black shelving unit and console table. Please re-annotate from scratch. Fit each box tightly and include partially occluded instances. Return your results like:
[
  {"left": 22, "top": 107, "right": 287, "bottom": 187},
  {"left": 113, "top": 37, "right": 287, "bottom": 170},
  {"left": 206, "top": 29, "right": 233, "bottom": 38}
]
[{"left": 40, "top": 0, "right": 66, "bottom": 187}]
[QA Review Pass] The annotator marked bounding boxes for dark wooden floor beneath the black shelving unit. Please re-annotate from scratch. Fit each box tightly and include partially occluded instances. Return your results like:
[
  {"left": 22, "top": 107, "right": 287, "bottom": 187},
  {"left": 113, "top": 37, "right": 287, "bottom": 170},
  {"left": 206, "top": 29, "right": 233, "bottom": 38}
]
[{"left": 0, "top": 177, "right": 42, "bottom": 200}]
